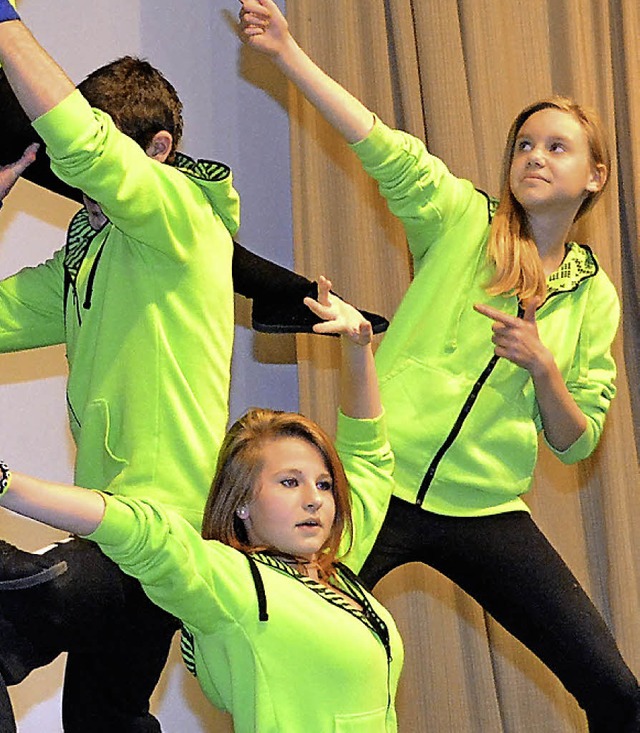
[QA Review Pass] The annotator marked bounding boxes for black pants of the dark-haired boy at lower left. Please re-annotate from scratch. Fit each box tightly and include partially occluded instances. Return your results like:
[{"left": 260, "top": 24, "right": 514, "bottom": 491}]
[{"left": 0, "top": 539, "right": 178, "bottom": 733}]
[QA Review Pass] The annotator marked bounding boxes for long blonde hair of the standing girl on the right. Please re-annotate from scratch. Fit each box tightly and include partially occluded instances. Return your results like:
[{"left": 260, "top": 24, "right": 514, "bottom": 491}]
[{"left": 487, "top": 96, "right": 611, "bottom": 301}]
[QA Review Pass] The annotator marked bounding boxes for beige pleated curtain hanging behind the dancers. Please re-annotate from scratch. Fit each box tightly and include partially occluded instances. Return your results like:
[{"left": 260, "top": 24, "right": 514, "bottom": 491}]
[{"left": 287, "top": 0, "right": 640, "bottom": 733}]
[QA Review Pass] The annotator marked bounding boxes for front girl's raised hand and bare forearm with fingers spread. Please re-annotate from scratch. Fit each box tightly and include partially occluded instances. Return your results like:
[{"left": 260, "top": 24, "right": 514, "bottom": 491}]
[{"left": 304, "top": 276, "right": 382, "bottom": 418}]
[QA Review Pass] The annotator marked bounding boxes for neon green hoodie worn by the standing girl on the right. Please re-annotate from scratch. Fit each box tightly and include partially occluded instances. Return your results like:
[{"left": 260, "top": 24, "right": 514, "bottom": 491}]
[{"left": 353, "top": 121, "right": 619, "bottom": 516}]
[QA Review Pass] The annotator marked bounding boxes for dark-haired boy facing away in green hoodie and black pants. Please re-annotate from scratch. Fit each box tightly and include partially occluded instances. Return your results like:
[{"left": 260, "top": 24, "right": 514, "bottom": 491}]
[{"left": 0, "top": 7, "right": 239, "bottom": 733}]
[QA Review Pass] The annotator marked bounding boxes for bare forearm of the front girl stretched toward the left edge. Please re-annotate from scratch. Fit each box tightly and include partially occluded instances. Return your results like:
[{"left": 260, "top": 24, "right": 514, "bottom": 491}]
[{"left": 0, "top": 463, "right": 105, "bottom": 535}]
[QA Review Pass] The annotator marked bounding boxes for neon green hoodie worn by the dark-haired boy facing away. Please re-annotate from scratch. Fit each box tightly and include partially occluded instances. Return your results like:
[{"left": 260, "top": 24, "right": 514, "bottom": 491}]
[{"left": 0, "top": 91, "right": 239, "bottom": 528}]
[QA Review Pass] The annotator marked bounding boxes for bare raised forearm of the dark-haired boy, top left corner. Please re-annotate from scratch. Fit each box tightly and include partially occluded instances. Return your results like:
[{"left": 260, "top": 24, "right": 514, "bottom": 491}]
[{"left": 0, "top": 0, "right": 75, "bottom": 120}]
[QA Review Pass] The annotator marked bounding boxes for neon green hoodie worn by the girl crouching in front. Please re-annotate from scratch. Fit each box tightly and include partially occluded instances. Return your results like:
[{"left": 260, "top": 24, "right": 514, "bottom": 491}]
[{"left": 89, "top": 415, "right": 403, "bottom": 733}]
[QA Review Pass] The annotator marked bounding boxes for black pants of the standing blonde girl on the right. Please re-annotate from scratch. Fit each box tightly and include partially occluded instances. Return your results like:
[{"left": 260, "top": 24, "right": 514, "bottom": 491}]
[{"left": 360, "top": 497, "right": 640, "bottom": 733}]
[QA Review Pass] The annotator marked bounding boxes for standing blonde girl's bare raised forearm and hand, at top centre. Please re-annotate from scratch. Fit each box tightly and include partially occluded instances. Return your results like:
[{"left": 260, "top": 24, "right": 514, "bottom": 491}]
[{"left": 240, "top": 0, "right": 374, "bottom": 143}]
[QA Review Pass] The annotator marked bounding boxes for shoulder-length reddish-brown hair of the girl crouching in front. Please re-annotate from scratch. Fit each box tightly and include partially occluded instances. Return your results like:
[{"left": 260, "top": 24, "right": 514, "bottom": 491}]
[{"left": 202, "top": 408, "right": 353, "bottom": 577}]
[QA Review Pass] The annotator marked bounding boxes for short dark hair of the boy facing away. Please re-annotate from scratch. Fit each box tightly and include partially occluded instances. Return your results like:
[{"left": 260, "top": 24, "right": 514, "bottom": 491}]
[{"left": 78, "top": 56, "right": 183, "bottom": 163}]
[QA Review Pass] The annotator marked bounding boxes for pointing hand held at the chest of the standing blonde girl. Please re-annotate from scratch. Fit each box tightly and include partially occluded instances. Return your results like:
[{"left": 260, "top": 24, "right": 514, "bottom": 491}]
[{"left": 473, "top": 298, "right": 553, "bottom": 376}]
